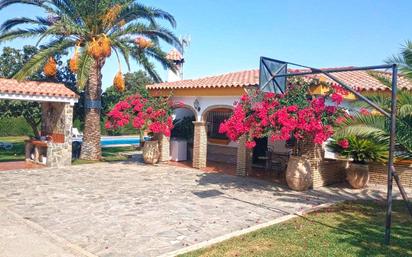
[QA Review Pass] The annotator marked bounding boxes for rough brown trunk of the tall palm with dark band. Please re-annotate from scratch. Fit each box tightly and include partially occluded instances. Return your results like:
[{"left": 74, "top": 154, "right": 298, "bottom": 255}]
[{"left": 80, "top": 60, "right": 104, "bottom": 160}]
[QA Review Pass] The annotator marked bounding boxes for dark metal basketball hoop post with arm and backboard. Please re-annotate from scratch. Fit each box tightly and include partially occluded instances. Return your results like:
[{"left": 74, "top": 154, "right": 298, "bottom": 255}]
[{"left": 260, "top": 57, "right": 412, "bottom": 245}]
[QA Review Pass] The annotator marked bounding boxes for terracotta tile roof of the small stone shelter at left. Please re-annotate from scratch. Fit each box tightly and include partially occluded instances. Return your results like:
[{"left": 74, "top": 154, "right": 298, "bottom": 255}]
[{"left": 0, "top": 78, "right": 78, "bottom": 98}]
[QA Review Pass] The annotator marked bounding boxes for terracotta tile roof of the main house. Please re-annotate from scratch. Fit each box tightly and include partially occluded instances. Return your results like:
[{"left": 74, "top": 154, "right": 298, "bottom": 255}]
[{"left": 147, "top": 69, "right": 412, "bottom": 91}]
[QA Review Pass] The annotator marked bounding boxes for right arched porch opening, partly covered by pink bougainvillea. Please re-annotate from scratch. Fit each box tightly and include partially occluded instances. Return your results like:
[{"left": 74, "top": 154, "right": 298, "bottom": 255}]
[{"left": 203, "top": 106, "right": 237, "bottom": 174}]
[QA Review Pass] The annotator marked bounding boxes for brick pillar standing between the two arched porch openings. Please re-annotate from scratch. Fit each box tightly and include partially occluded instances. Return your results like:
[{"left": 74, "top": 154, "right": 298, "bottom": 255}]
[{"left": 192, "top": 121, "right": 207, "bottom": 169}]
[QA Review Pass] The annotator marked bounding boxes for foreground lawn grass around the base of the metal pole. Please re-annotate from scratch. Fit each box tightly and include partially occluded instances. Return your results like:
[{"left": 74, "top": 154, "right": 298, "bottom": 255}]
[{"left": 180, "top": 201, "right": 412, "bottom": 257}]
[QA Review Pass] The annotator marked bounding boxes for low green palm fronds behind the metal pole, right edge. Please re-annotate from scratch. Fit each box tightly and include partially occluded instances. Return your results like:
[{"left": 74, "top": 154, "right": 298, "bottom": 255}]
[{"left": 335, "top": 91, "right": 412, "bottom": 159}]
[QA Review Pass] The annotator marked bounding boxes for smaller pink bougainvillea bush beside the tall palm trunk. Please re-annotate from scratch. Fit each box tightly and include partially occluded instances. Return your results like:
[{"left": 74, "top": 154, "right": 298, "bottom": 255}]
[{"left": 105, "top": 94, "right": 178, "bottom": 136}]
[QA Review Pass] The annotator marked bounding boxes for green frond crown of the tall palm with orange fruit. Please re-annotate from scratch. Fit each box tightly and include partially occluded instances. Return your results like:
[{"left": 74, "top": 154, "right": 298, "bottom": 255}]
[{"left": 0, "top": 0, "right": 181, "bottom": 85}]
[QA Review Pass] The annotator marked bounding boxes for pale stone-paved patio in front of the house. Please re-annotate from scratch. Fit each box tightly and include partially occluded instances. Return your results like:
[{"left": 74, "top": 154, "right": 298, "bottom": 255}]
[{"left": 0, "top": 163, "right": 408, "bottom": 257}]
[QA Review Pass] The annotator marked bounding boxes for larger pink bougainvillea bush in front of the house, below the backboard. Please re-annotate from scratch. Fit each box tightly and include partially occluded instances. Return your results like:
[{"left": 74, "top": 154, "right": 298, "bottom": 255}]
[{"left": 219, "top": 79, "right": 347, "bottom": 148}]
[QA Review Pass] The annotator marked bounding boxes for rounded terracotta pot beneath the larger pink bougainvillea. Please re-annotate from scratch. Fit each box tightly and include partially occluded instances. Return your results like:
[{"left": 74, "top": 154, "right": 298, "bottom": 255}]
[{"left": 286, "top": 156, "right": 312, "bottom": 191}]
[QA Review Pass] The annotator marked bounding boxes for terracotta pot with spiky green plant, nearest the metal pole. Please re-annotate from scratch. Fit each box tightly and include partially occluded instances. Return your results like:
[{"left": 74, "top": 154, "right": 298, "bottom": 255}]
[{"left": 328, "top": 136, "right": 388, "bottom": 189}]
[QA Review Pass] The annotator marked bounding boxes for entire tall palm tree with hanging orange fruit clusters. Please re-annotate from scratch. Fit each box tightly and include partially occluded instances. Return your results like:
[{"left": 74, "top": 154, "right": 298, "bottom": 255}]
[{"left": 0, "top": 0, "right": 180, "bottom": 160}]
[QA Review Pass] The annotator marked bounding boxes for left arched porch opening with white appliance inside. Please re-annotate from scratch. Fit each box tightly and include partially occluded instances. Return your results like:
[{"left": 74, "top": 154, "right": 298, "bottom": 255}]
[{"left": 170, "top": 106, "right": 197, "bottom": 166}]
